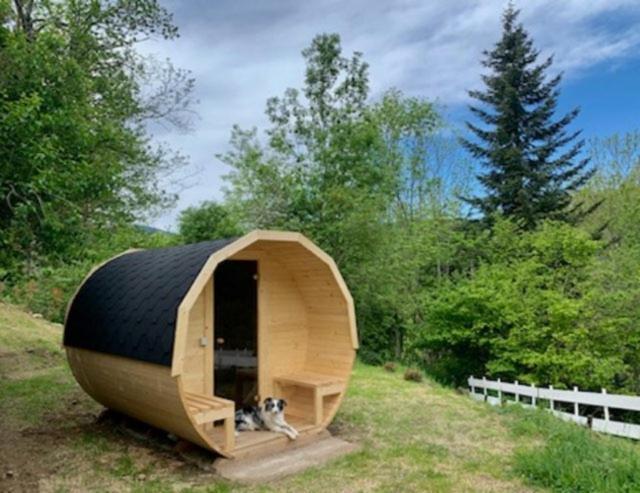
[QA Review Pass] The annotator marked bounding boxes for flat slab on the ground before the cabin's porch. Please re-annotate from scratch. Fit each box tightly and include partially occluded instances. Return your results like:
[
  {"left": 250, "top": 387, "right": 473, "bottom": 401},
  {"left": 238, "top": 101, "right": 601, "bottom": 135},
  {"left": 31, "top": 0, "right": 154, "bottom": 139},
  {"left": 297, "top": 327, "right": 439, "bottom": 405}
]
[{"left": 213, "top": 436, "right": 358, "bottom": 483}]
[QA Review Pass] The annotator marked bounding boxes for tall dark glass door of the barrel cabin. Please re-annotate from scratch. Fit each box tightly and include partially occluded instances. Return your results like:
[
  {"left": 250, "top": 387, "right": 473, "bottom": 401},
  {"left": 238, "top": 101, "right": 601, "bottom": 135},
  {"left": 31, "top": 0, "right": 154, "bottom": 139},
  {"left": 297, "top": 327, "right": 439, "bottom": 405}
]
[{"left": 213, "top": 260, "right": 259, "bottom": 408}]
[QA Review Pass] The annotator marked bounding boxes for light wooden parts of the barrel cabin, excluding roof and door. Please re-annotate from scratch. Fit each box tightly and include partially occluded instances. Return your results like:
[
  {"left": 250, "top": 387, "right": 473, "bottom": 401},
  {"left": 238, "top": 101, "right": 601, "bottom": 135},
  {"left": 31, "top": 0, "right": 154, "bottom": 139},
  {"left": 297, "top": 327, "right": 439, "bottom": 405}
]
[{"left": 67, "top": 231, "right": 358, "bottom": 457}]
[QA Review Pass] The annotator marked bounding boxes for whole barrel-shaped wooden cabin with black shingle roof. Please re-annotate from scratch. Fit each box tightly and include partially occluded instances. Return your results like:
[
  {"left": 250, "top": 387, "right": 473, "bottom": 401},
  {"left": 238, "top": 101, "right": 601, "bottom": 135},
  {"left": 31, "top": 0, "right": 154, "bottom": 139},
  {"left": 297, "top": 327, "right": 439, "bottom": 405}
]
[{"left": 64, "top": 231, "right": 358, "bottom": 457}]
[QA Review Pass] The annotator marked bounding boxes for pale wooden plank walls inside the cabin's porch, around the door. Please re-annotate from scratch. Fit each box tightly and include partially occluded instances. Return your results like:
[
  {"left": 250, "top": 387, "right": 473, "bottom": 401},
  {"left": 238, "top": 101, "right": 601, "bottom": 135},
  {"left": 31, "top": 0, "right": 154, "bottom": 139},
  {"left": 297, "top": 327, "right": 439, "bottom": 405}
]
[{"left": 183, "top": 240, "right": 355, "bottom": 434}]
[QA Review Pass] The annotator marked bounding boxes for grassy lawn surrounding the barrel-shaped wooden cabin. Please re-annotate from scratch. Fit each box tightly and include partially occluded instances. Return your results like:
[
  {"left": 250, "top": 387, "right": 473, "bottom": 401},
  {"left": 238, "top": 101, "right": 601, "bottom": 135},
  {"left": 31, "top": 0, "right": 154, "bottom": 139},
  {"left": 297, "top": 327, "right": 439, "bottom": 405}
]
[{"left": 0, "top": 304, "right": 640, "bottom": 493}]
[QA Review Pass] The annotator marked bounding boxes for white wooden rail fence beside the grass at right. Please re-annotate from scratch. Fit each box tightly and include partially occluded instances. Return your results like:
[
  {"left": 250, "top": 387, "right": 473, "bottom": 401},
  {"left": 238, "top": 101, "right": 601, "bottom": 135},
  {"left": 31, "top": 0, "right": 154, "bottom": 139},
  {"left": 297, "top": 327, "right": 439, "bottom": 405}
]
[{"left": 468, "top": 377, "right": 640, "bottom": 440}]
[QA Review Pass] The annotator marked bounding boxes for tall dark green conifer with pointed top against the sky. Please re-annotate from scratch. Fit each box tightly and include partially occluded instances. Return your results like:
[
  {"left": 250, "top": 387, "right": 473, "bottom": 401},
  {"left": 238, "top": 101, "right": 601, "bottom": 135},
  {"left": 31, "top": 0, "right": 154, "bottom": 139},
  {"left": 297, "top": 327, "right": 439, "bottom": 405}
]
[{"left": 462, "top": 4, "right": 593, "bottom": 229}]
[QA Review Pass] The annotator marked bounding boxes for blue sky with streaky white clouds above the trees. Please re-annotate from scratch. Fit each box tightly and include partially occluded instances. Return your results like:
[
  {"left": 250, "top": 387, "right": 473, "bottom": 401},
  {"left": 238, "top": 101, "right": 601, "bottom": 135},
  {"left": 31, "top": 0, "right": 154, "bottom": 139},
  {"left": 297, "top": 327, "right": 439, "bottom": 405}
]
[{"left": 140, "top": 0, "right": 640, "bottom": 229}]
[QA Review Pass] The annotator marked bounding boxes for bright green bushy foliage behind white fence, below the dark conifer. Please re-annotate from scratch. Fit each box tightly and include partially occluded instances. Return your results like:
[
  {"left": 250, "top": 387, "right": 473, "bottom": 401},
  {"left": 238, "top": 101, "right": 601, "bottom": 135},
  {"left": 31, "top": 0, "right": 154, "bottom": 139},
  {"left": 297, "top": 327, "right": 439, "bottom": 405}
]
[{"left": 415, "top": 220, "right": 626, "bottom": 388}]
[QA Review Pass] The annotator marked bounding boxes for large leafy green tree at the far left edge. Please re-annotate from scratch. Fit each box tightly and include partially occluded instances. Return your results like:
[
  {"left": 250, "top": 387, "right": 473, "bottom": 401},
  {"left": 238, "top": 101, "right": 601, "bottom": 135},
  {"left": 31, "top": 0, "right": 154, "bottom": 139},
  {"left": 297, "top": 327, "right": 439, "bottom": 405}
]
[{"left": 0, "top": 0, "right": 192, "bottom": 277}]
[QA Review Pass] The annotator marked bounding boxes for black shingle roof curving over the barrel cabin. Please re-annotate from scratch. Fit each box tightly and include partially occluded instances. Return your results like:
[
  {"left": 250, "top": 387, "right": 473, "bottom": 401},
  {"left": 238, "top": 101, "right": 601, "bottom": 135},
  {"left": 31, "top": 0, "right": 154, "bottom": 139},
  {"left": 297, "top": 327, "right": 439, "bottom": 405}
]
[{"left": 64, "top": 238, "right": 235, "bottom": 366}]
